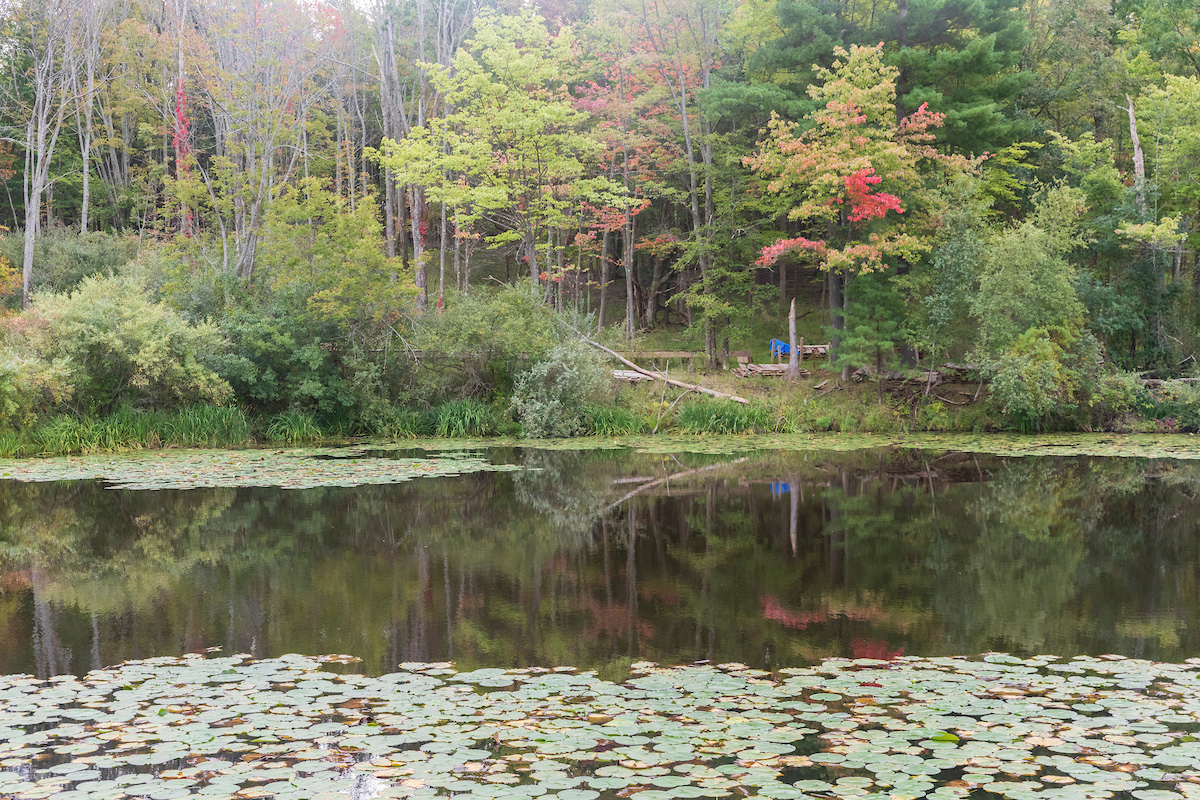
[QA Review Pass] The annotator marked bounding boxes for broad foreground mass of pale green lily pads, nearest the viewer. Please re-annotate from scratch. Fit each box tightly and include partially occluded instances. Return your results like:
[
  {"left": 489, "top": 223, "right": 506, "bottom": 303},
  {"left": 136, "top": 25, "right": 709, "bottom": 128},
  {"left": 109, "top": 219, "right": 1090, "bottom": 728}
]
[{"left": 0, "top": 655, "right": 1200, "bottom": 800}]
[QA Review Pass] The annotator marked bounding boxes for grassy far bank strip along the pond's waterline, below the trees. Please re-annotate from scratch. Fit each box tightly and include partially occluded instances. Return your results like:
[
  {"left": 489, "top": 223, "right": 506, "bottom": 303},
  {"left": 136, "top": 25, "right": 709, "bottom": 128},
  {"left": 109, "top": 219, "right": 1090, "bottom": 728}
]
[{"left": 9, "top": 363, "right": 1200, "bottom": 458}]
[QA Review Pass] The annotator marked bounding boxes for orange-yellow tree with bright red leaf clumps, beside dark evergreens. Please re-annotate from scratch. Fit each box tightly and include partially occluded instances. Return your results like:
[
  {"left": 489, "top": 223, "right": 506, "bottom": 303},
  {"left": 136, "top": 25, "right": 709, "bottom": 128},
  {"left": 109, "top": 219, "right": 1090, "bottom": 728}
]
[{"left": 745, "top": 44, "right": 977, "bottom": 369}]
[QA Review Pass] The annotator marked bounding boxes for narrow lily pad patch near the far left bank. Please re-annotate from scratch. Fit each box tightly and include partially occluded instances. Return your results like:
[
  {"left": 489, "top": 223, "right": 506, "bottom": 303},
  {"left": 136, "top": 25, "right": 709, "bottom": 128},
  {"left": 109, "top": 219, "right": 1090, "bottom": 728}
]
[{"left": 0, "top": 447, "right": 520, "bottom": 489}]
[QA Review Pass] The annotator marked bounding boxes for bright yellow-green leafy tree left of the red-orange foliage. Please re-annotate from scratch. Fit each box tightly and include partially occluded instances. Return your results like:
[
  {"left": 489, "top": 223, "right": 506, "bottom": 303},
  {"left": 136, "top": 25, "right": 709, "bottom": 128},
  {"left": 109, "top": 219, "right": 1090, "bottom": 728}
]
[{"left": 380, "top": 11, "right": 618, "bottom": 297}]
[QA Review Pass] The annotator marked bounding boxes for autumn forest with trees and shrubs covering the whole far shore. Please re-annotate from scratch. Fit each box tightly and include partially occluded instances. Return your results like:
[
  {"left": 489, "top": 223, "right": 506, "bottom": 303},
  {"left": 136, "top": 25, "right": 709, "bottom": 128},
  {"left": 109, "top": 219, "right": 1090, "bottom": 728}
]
[{"left": 0, "top": 0, "right": 1200, "bottom": 443}]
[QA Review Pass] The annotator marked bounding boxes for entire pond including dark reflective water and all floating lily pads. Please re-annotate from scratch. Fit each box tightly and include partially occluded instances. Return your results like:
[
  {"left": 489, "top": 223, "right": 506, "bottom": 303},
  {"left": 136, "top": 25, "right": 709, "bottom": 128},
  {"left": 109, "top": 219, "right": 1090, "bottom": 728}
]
[{"left": 0, "top": 437, "right": 1200, "bottom": 800}]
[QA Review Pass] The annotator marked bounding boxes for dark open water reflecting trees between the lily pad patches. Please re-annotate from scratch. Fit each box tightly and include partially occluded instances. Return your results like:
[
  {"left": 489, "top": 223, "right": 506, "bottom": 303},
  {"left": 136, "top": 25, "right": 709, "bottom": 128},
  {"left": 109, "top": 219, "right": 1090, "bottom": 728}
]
[{"left": 0, "top": 449, "right": 1200, "bottom": 676}]
